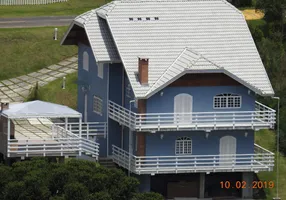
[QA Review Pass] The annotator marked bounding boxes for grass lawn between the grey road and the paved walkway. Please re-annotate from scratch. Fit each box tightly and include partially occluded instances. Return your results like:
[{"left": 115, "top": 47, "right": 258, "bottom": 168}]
[{"left": 0, "top": 26, "right": 77, "bottom": 80}]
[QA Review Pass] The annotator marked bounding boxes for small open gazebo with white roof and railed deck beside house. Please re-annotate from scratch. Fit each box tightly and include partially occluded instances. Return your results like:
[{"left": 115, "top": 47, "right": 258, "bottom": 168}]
[{"left": 0, "top": 101, "right": 103, "bottom": 160}]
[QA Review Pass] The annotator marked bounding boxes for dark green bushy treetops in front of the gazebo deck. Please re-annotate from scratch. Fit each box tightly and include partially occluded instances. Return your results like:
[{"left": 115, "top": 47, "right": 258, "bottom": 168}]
[{"left": 0, "top": 158, "right": 163, "bottom": 200}]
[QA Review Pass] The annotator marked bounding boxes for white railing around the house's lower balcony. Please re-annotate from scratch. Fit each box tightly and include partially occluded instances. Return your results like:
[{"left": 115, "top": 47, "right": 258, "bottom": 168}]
[{"left": 112, "top": 144, "right": 274, "bottom": 174}]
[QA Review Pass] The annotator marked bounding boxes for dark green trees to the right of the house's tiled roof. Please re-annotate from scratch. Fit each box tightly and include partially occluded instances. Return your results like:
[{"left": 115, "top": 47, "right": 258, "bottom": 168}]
[{"left": 248, "top": 0, "right": 286, "bottom": 155}]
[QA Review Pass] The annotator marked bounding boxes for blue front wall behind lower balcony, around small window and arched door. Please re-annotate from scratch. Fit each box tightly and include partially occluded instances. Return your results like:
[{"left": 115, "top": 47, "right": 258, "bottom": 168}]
[{"left": 146, "top": 130, "right": 254, "bottom": 156}]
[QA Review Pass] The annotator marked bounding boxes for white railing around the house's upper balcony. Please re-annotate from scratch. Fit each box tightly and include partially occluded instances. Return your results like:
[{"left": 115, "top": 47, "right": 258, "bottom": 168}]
[{"left": 108, "top": 101, "right": 275, "bottom": 131}]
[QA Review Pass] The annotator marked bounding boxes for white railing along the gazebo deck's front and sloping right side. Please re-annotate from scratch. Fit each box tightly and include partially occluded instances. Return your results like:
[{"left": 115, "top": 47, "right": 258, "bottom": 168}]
[{"left": 7, "top": 125, "right": 99, "bottom": 159}]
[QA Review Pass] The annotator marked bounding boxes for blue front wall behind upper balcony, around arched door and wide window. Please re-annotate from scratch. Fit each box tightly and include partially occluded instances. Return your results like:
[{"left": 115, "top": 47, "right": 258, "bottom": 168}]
[{"left": 147, "top": 86, "right": 255, "bottom": 113}]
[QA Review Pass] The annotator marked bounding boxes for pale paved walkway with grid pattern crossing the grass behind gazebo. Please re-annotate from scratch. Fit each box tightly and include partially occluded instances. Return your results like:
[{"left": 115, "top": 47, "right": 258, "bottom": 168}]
[{"left": 0, "top": 57, "right": 77, "bottom": 102}]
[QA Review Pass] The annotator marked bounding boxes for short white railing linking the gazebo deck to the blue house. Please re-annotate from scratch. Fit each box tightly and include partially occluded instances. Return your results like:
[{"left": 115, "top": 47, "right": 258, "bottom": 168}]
[{"left": 56, "top": 122, "right": 107, "bottom": 139}]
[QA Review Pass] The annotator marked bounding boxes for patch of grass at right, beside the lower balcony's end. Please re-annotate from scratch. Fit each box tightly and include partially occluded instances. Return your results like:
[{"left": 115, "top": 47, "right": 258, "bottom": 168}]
[{"left": 255, "top": 130, "right": 286, "bottom": 200}]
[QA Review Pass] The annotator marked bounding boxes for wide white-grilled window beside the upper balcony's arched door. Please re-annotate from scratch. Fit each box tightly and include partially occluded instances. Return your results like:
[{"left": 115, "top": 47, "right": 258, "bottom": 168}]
[{"left": 213, "top": 94, "right": 241, "bottom": 108}]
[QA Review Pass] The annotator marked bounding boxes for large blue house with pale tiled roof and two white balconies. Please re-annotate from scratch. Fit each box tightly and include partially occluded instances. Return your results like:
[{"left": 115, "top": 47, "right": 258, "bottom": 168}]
[{"left": 62, "top": 0, "right": 275, "bottom": 199}]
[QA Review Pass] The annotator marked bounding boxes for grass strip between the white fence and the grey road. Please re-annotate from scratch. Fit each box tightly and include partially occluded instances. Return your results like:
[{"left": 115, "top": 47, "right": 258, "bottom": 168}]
[{"left": 0, "top": 0, "right": 108, "bottom": 17}]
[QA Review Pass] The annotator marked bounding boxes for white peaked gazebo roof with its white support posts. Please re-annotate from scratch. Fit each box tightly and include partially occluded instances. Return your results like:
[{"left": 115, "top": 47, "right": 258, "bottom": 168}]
[{"left": 1, "top": 100, "right": 82, "bottom": 140}]
